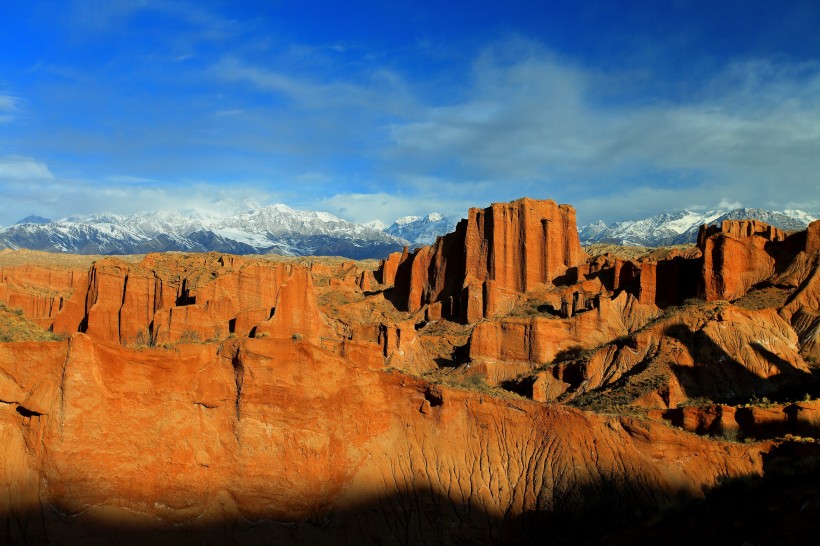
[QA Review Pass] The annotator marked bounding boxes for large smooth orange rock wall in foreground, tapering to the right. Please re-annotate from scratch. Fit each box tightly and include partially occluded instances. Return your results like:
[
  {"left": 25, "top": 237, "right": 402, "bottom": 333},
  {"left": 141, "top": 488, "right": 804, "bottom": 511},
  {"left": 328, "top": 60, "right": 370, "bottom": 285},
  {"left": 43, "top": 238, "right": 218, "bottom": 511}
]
[{"left": 0, "top": 334, "right": 765, "bottom": 543}]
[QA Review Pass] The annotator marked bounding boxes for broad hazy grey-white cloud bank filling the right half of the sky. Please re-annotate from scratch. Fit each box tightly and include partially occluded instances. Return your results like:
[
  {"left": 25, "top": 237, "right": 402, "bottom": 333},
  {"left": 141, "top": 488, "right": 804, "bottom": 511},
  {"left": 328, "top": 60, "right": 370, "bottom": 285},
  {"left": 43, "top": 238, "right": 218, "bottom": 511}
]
[{"left": 387, "top": 41, "right": 820, "bottom": 219}]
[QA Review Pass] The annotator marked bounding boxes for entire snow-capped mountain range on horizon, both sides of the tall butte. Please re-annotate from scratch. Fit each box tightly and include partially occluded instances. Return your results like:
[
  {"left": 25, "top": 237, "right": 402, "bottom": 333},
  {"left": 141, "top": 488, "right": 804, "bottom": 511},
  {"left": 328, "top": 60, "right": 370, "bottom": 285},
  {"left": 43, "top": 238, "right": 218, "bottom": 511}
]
[{"left": 0, "top": 205, "right": 817, "bottom": 259}]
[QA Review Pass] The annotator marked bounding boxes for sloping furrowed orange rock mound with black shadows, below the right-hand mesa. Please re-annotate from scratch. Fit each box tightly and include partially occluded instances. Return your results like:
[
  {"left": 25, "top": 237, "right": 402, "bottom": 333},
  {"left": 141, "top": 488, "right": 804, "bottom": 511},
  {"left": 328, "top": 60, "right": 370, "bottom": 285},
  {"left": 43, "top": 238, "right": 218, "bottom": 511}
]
[{"left": 558, "top": 304, "right": 812, "bottom": 407}]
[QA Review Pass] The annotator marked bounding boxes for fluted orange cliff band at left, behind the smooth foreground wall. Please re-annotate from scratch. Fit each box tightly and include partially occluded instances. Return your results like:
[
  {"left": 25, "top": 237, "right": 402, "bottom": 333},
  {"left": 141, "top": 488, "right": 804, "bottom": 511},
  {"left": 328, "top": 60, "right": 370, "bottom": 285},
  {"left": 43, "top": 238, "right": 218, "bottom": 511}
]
[{"left": 0, "top": 255, "right": 330, "bottom": 345}]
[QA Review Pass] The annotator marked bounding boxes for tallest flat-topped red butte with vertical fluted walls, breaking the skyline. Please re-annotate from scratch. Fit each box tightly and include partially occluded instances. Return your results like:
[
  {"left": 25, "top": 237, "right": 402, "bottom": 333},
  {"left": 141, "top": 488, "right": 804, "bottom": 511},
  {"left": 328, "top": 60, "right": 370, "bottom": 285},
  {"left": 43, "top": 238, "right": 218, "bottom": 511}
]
[{"left": 379, "top": 198, "right": 587, "bottom": 322}]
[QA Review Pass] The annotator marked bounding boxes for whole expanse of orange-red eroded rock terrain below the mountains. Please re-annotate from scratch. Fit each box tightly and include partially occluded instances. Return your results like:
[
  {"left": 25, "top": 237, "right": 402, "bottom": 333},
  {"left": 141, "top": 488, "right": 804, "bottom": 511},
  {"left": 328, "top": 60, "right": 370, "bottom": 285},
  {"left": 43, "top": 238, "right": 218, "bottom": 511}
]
[{"left": 0, "top": 199, "right": 820, "bottom": 544}]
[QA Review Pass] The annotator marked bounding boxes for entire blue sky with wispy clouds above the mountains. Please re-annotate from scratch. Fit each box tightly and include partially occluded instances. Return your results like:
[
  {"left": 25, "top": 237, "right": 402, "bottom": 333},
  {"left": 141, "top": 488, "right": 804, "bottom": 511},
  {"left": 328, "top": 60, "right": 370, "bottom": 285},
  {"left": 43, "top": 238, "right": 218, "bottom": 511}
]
[{"left": 0, "top": 0, "right": 820, "bottom": 225}]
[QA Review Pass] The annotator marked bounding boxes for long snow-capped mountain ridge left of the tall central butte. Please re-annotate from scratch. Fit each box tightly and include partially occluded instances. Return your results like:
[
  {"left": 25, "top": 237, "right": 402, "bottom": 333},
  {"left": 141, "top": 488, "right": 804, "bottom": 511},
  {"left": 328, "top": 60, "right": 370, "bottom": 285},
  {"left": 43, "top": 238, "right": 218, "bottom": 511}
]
[{"left": 0, "top": 205, "right": 408, "bottom": 259}]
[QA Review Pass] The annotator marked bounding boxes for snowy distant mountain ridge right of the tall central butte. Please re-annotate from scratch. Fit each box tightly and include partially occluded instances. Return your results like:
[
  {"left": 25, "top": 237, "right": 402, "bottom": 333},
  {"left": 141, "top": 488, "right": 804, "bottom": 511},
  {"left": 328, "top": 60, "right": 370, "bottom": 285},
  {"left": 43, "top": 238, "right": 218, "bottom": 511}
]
[{"left": 578, "top": 208, "right": 817, "bottom": 246}]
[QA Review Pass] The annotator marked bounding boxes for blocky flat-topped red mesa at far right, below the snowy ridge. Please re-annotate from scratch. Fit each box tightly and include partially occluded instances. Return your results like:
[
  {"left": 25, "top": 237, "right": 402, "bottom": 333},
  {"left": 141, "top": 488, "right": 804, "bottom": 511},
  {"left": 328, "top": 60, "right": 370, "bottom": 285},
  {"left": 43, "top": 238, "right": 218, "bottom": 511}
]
[{"left": 698, "top": 220, "right": 786, "bottom": 301}]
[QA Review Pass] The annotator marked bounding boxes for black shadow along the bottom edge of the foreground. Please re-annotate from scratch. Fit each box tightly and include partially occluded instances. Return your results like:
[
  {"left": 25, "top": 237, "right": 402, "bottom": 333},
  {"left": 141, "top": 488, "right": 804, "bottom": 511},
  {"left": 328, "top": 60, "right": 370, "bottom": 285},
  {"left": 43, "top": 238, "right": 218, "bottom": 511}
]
[{"left": 6, "top": 443, "right": 820, "bottom": 545}]
